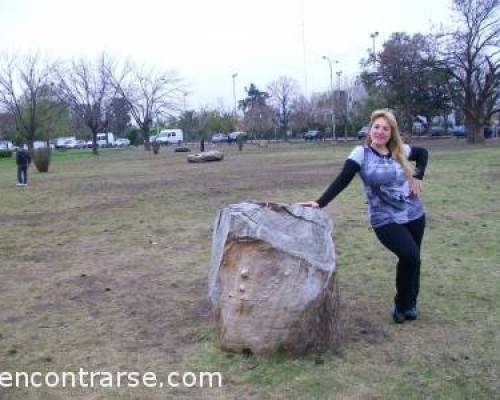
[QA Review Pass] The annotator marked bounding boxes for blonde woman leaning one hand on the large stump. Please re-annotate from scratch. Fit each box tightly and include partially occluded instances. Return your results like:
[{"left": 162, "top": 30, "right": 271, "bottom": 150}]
[{"left": 299, "top": 110, "right": 427, "bottom": 323}]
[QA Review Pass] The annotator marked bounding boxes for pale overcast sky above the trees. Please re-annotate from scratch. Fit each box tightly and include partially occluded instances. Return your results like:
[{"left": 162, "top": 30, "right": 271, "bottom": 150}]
[{"left": 0, "top": 0, "right": 451, "bottom": 108}]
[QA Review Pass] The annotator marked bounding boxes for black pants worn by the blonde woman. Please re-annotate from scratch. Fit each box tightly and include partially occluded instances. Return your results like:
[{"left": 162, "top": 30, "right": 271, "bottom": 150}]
[{"left": 374, "top": 215, "right": 425, "bottom": 311}]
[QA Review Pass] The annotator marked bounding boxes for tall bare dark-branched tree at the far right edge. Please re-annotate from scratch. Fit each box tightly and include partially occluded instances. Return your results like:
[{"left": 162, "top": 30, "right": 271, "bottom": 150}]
[{"left": 440, "top": 0, "right": 500, "bottom": 143}]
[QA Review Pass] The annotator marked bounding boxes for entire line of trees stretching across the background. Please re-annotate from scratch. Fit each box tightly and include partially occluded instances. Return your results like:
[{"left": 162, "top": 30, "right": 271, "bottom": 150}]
[{"left": 0, "top": 0, "right": 500, "bottom": 147}]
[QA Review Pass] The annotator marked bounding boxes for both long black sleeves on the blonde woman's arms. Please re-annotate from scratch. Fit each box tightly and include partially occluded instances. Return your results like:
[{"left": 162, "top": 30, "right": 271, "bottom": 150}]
[{"left": 316, "top": 146, "right": 429, "bottom": 208}]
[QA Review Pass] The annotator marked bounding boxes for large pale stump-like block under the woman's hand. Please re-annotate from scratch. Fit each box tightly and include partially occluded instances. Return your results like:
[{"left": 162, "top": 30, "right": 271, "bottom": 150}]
[{"left": 208, "top": 203, "right": 342, "bottom": 355}]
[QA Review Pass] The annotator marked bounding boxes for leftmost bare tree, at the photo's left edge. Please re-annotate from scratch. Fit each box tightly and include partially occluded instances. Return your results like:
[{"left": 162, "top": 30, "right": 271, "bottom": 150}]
[{"left": 0, "top": 53, "right": 55, "bottom": 151}]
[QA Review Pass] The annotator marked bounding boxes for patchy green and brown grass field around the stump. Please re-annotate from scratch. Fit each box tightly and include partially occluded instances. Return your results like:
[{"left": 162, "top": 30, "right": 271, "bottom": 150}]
[{"left": 0, "top": 139, "right": 500, "bottom": 400}]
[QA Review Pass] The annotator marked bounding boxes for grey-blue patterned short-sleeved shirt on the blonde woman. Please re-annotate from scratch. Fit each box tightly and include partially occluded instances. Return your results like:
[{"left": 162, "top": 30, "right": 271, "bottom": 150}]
[{"left": 348, "top": 144, "right": 424, "bottom": 228}]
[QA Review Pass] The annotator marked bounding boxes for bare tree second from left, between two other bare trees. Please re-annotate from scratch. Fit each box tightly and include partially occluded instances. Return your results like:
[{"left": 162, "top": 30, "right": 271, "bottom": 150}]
[{"left": 56, "top": 54, "right": 114, "bottom": 154}]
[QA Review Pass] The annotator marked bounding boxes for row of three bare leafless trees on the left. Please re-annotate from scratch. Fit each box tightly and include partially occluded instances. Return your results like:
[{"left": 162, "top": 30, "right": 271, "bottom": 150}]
[{"left": 0, "top": 53, "right": 185, "bottom": 153}]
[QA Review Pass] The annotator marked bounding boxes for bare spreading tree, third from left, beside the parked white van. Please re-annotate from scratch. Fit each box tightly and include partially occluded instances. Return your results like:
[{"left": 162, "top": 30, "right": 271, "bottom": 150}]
[{"left": 110, "top": 63, "right": 186, "bottom": 150}]
